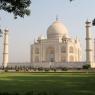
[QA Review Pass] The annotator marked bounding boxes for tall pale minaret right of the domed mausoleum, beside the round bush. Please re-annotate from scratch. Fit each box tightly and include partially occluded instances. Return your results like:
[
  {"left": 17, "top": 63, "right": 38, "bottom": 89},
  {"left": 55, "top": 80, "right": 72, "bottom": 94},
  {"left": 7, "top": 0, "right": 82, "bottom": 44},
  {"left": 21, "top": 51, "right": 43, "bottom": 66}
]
[{"left": 85, "top": 21, "right": 93, "bottom": 66}]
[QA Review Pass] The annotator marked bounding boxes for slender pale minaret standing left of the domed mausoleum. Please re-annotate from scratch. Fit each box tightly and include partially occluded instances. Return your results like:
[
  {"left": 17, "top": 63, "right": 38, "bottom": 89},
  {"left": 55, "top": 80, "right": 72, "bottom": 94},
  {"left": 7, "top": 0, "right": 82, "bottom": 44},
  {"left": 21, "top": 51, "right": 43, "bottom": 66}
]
[{"left": 3, "top": 28, "right": 9, "bottom": 68}]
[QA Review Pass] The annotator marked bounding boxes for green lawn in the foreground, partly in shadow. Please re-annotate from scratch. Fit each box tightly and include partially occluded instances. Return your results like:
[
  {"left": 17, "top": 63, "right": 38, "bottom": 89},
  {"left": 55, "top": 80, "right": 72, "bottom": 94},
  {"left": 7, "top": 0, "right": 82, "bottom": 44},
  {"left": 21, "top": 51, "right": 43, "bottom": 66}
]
[{"left": 0, "top": 73, "right": 95, "bottom": 95}]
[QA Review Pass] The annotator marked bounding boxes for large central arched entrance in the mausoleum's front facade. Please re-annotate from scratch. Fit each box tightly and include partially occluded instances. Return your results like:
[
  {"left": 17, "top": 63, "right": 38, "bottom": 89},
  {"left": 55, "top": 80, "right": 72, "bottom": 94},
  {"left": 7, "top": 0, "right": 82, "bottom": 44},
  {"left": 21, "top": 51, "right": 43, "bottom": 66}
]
[{"left": 46, "top": 47, "right": 55, "bottom": 62}]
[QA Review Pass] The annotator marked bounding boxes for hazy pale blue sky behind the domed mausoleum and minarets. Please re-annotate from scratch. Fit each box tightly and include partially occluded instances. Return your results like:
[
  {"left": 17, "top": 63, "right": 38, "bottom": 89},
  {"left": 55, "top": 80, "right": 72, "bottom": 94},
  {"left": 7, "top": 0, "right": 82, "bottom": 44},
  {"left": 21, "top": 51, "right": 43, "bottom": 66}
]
[{"left": 0, "top": 0, "right": 95, "bottom": 63}]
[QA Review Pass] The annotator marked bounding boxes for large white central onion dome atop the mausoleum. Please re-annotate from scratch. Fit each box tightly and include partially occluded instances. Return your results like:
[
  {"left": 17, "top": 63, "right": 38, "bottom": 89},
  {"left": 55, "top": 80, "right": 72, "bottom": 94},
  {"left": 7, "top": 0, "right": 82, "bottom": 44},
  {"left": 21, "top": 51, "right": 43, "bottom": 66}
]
[{"left": 47, "top": 21, "right": 68, "bottom": 39}]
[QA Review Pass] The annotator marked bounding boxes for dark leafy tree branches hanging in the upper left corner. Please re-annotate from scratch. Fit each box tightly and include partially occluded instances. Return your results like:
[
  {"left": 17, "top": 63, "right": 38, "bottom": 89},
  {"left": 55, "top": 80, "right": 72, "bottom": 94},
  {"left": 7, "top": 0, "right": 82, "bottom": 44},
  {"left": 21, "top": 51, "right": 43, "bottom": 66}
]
[{"left": 0, "top": 0, "right": 31, "bottom": 19}]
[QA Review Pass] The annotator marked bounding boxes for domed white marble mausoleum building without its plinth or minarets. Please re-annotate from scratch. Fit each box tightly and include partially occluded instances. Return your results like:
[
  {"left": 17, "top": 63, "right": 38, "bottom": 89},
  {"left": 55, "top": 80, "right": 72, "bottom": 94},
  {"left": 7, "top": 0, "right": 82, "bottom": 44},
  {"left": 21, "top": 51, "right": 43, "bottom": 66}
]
[{"left": 31, "top": 21, "right": 81, "bottom": 63}]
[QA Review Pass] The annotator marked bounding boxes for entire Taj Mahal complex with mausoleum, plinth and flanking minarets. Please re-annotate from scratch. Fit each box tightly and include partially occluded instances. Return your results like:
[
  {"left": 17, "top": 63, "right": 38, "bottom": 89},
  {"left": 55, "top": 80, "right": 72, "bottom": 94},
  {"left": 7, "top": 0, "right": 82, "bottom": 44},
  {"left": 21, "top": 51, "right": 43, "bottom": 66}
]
[{"left": 3, "top": 19, "right": 95, "bottom": 68}]
